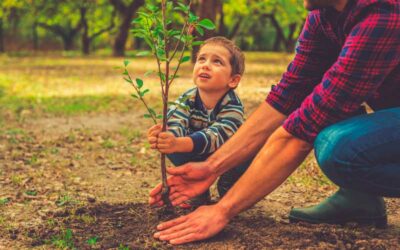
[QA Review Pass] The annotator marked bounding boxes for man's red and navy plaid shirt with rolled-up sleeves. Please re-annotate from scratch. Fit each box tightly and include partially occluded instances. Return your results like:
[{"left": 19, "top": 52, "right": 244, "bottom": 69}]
[{"left": 266, "top": 0, "right": 400, "bottom": 143}]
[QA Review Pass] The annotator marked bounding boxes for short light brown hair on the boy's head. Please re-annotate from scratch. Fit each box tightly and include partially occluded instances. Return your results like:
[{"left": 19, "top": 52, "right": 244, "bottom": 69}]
[{"left": 200, "top": 36, "right": 244, "bottom": 76}]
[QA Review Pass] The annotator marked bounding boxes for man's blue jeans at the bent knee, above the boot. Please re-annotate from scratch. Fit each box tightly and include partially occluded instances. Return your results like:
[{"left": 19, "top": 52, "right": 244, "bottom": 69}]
[{"left": 314, "top": 107, "right": 400, "bottom": 197}]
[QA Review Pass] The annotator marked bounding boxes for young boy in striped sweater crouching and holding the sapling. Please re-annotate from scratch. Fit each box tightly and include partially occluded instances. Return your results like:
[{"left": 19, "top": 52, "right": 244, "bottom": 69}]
[{"left": 148, "top": 37, "right": 248, "bottom": 206}]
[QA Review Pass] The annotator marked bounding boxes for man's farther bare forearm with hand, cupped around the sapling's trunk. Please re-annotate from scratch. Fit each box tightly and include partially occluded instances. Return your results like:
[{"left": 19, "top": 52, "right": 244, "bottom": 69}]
[{"left": 149, "top": 102, "right": 286, "bottom": 205}]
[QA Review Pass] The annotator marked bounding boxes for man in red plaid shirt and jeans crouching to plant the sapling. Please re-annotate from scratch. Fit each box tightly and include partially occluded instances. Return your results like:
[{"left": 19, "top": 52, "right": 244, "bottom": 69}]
[{"left": 150, "top": 0, "right": 400, "bottom": 244}]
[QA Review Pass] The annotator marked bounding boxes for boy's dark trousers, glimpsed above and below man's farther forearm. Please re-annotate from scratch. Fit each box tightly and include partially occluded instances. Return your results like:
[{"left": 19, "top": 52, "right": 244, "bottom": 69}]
[{"left": 167, "top": 153, "right": 253, "bottom": 197}]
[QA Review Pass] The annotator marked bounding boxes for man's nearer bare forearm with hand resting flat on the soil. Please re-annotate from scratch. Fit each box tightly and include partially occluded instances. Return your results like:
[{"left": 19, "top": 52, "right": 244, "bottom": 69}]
[{"left": 154, "top": 127, "right": 312, "bottom": 244}]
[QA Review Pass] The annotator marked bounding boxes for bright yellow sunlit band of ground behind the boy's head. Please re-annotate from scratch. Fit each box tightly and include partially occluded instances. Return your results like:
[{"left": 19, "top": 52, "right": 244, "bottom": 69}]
[{"left": 0, "top": 52, "right": 291, "bottom": 98}]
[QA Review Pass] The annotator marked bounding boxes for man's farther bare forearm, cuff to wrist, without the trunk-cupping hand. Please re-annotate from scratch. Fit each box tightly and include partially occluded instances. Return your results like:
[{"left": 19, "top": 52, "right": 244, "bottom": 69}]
[{"left": 207, "top": 102, "right": 286, "bottom": 176}]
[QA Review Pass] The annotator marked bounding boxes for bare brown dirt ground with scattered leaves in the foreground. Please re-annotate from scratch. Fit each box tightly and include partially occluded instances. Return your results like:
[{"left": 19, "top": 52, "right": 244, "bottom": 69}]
[{"left": 0, "top": 109, "right": 400, "bottom": 249}]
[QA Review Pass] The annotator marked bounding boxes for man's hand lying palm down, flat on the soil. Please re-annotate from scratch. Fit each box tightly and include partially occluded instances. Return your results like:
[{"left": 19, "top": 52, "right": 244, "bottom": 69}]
[{"left": 154, "top": 205, "right": 229, "bottom": 245}]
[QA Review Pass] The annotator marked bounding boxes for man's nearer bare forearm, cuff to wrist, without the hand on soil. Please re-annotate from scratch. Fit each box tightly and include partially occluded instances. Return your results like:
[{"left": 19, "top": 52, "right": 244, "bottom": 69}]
[{"left": 218, "top": 127, "right": 312, "bottom": 218}]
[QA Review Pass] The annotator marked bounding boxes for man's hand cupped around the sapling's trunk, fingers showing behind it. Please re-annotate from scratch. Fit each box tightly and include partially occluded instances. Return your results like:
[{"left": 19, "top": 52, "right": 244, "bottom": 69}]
[{"left": 149, "top": 162, "right": 217, "bottom": 206}]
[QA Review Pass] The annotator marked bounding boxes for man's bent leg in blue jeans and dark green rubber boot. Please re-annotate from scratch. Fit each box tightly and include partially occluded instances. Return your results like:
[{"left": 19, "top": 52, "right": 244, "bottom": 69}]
[{"left": 289, "top": 108, "right": 400, "bottom": 226}]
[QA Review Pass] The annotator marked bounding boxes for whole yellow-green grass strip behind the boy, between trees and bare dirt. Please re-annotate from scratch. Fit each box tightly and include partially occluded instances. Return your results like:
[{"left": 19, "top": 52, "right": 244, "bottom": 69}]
[{"left": 0, "top": 52, "right": 292, "bottom": 119}]
